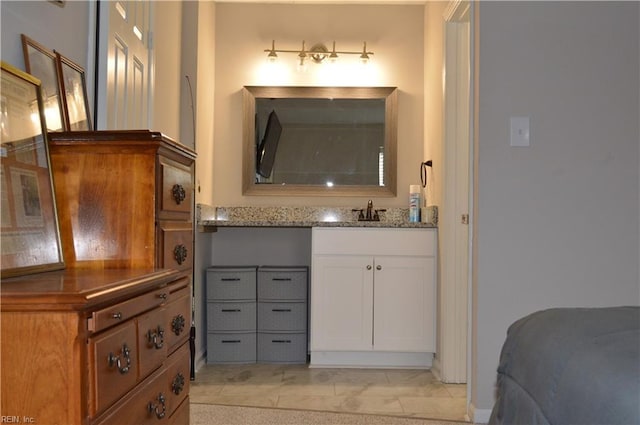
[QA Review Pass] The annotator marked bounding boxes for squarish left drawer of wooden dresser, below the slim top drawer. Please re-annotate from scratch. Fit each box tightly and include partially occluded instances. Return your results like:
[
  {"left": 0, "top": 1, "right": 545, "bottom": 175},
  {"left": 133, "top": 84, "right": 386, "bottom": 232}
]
[{"left": 89, "top": 320, "right": 138, "bottom": 415}]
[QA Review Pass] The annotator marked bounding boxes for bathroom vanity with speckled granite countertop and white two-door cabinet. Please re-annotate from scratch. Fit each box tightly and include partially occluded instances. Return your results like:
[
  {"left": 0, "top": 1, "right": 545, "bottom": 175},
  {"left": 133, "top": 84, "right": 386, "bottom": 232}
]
[{"left": 200, "top": 207, "right": 437, "bottom": 368}]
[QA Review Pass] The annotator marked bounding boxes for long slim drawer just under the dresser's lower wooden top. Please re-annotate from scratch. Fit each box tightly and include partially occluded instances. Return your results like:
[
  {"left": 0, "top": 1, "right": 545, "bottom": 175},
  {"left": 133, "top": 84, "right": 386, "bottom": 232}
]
[{"left": 89, "top": 288, "right": 168, "bottom": 332}]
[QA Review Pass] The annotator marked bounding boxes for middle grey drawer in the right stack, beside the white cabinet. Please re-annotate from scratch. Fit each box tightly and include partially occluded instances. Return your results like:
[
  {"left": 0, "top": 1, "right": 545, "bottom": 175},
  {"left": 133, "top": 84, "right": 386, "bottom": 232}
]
[{"left": 258, "top": 302, "right": 307, "bottom": 332}]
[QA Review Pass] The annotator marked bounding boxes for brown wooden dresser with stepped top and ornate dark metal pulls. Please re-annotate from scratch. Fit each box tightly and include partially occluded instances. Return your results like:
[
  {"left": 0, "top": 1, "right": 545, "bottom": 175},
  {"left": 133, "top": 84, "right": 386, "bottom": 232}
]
[{"left": 0, "top": 130, "right": 195, "bottom": 425}]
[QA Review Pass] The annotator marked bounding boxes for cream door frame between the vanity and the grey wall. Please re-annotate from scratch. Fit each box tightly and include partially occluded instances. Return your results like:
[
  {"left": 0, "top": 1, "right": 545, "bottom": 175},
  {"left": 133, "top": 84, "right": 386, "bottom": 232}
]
[{"left": 438, "top": 0, "right": 474, "bottom": 388}]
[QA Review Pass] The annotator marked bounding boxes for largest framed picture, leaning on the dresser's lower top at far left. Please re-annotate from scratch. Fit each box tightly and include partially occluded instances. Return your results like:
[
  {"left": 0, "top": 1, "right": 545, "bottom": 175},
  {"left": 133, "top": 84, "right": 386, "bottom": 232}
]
[{"left": 0, "top": 62, "right": 64, "bottom": 278}]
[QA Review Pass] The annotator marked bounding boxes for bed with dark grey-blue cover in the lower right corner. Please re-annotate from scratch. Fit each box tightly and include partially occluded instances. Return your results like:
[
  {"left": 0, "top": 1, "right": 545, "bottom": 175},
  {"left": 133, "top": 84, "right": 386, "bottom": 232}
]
[{"left": 489, "top": 307, "right": 640, "bottom": 425}]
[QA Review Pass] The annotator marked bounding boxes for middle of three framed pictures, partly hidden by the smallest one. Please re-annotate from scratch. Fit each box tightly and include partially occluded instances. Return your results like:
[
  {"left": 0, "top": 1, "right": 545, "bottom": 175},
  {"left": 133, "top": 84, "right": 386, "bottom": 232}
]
[{"left": 21, "top": 34, "right": 64, "bottom": 131}]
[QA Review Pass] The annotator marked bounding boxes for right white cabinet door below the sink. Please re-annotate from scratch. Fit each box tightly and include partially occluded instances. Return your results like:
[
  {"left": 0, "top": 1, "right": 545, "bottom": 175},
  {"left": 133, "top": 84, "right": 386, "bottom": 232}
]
[{"left": 373, "top": 256, "right": 435, "bottom": 352}]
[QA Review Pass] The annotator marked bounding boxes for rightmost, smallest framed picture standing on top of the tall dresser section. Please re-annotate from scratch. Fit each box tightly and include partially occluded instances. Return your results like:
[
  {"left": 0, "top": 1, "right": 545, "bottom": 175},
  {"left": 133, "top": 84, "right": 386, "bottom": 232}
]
[{"left": 54, "top": 50, "right": 93, "bottom": 131}]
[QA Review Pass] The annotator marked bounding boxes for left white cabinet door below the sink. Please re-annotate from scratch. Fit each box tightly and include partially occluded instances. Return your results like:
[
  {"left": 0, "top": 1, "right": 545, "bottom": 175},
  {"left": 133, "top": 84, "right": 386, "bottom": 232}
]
[{"left": 311, "top": 255, "right": 373, "bottom": 351}]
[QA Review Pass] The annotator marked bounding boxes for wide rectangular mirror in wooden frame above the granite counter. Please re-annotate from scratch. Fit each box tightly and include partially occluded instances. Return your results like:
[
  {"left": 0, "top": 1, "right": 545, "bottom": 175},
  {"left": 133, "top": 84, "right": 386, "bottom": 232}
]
[{"left": 243, "top": 86, "right": 397, "bottom": 197}]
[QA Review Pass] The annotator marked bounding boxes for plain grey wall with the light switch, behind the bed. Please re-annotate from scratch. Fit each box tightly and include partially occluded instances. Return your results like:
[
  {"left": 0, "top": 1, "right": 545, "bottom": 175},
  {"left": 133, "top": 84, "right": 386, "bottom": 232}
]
[{"left": 472, "top": 1, "right": 640, "bottom": 416}]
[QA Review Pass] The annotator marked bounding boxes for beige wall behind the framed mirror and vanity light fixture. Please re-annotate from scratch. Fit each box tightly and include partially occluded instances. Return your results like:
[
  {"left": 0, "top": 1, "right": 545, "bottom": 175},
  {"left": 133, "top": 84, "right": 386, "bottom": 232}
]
[{"left": 211, "top": 3, "right": 424, "bottom": 207}]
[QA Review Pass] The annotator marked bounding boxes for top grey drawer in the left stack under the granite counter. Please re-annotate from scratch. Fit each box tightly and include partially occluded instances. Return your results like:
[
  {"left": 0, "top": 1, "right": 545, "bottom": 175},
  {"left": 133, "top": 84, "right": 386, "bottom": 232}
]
[{"left": 207, "top": 267, "right": 256, "bottom": 300}]
